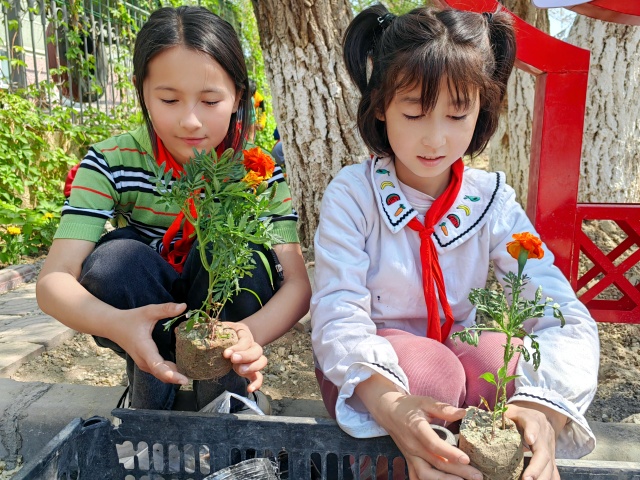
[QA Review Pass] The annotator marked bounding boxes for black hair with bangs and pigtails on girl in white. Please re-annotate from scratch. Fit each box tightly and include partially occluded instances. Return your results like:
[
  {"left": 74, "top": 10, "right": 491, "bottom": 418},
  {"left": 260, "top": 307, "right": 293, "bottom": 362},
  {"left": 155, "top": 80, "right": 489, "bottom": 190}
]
[{"left": 343, "top": 4, "right": 516, "bottom": 156}]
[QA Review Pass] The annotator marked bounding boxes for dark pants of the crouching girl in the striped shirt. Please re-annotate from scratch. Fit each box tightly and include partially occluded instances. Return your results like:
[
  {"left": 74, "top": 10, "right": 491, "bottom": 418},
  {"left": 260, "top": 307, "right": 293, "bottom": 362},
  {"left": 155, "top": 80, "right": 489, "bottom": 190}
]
[{"left": 79, "top": 227, "right": 277, "bottom": 410}]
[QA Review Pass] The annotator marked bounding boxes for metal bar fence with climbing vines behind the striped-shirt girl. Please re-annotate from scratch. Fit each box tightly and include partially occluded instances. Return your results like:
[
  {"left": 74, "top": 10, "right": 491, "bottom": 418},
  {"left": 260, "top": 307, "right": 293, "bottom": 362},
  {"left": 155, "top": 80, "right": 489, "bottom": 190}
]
[{"left": 0, "top": 0, "right": 149, "bottom": 122}]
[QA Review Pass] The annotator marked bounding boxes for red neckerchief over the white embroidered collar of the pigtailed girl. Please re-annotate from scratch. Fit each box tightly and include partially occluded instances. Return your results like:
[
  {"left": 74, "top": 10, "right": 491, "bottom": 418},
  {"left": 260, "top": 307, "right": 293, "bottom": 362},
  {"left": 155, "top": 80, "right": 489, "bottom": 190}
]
[{"left": 407, "top": 159, "right": 464, "bottom": 343}]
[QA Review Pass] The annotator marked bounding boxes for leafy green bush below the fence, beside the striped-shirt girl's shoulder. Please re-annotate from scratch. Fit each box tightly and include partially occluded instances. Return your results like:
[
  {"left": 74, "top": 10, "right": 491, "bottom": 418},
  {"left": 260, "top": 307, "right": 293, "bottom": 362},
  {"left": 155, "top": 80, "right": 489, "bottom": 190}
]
[{"left": 0, "top": 85, "right": 137, "bottom": 265}]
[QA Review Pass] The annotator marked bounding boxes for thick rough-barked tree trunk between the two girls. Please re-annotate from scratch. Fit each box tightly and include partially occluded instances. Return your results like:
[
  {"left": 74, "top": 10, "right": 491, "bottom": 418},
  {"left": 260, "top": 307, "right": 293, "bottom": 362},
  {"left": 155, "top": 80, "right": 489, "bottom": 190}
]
[{"left": 252, "top": 0, "right": 366, "bottom": 247}]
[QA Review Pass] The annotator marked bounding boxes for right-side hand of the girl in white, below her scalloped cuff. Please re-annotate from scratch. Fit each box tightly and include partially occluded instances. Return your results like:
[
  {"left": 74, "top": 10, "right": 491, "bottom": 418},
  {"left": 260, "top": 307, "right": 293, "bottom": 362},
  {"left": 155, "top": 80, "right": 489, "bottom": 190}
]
[{"left": 507, "top": 402, "right": 567, "bottom": 480}]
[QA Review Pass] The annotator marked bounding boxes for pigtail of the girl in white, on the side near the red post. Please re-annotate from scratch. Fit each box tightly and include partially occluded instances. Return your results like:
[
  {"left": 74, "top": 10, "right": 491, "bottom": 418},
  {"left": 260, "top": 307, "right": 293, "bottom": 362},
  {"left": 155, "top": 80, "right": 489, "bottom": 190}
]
[{"left": 483, "top": 10, "right": 516, "bottom": 100}]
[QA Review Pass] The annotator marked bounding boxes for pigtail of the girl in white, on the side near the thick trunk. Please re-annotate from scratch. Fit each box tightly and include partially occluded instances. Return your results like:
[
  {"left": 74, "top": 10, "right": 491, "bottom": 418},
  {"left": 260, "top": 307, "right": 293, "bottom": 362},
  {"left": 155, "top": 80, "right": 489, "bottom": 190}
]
[{"left": 342, "top": 4, "right": 390, "bottom": 95}]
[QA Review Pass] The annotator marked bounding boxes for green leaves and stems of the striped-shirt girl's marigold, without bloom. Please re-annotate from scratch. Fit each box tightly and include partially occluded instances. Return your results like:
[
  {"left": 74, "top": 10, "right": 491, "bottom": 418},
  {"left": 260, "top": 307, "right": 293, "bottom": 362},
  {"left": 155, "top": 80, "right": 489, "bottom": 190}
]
[{"left": 155, "top": 149, "right": 277, "bottom": 330}]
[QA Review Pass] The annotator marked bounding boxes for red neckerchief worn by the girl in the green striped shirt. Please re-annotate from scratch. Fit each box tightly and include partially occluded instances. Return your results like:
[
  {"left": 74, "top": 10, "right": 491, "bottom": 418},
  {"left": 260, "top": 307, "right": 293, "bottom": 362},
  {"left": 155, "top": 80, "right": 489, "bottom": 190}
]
[{"left": 156, "top": 139, "right": 224, "bottom": 273}]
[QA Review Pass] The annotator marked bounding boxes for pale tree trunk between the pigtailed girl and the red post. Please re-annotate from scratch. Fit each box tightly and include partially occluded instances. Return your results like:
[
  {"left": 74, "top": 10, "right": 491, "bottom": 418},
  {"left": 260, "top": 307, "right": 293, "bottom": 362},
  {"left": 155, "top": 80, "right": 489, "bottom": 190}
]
[{"left": 488, "top": 0, "right": 549, "bottom": 206}]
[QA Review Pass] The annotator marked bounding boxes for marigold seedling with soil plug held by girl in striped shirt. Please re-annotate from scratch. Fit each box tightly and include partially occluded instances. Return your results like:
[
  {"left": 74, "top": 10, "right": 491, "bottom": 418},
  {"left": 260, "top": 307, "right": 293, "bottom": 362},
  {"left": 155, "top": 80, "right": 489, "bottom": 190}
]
[{"left": 155, "top": 147, "right": 279, "bottom": 380}]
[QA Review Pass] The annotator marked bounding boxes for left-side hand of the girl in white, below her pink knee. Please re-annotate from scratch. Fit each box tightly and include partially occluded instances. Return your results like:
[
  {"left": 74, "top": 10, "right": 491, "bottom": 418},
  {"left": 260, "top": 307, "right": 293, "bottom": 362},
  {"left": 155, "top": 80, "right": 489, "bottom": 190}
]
[{"left": 356, "top": 375, "right": 482, "bottom": 480}]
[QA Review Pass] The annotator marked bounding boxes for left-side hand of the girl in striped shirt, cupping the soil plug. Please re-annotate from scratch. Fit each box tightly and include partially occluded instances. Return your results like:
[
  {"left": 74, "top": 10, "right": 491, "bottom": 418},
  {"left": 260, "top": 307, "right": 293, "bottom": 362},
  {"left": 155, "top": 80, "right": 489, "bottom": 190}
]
[{"left": 109, "top": 303, "right": 189, "bottom": 385}]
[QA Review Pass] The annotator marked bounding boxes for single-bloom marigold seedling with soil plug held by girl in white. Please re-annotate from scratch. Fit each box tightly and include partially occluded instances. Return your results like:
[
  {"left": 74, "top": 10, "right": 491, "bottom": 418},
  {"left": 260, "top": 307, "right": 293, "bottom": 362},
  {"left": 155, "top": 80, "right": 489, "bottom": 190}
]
[{"left": 452, "top": 232, "right": 565, "bottom": 480}]
